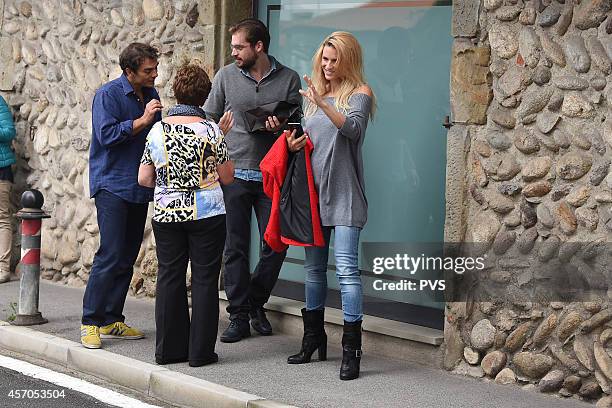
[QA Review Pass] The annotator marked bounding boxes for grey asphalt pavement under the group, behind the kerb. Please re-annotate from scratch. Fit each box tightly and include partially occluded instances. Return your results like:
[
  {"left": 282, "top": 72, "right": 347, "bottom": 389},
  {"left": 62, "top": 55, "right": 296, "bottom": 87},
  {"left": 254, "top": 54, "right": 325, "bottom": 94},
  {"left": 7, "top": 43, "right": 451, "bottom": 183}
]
[{"left": 0, "top": 282, "right": 593, "bottom": 408}]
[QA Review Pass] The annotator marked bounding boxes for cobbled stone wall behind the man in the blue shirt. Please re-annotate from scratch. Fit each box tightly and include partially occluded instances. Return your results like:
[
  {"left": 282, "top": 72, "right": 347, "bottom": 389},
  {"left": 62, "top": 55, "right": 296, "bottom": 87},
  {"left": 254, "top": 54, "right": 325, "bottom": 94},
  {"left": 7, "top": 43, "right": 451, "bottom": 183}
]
[{"left": 0, "top": 0, "right": 252, "bottom": 296}]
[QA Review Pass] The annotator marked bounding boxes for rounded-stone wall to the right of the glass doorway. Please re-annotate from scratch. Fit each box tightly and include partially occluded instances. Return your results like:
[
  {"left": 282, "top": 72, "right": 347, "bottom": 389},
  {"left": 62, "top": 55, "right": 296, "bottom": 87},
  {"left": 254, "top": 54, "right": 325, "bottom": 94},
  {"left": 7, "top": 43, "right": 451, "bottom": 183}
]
[{"left": 444, "top": 0, "right": 612, "bottom": 407}]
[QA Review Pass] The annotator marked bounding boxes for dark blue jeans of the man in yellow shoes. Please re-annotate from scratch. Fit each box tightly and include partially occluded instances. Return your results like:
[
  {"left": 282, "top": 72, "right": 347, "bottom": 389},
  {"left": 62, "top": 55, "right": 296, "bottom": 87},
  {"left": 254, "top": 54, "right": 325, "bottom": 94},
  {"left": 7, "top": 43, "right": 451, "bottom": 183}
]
[{"left": 82, "top": 190, "right": 149, "bottom": 326}]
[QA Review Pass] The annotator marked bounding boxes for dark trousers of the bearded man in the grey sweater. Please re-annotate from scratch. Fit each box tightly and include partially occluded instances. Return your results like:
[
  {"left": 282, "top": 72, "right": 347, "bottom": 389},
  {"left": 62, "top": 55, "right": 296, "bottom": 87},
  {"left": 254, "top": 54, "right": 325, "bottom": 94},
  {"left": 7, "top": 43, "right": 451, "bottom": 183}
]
[{"left": 223, "top": 179, "right": 286, "bottom": 320}]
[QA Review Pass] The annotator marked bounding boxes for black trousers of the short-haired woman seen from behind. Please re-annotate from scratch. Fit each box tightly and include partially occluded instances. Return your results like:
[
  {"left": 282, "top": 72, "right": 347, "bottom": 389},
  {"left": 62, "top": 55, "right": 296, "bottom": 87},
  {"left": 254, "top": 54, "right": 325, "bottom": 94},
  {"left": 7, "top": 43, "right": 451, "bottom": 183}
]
[{"left": 152, "top": 215, "right": 225, "bottom": 363}]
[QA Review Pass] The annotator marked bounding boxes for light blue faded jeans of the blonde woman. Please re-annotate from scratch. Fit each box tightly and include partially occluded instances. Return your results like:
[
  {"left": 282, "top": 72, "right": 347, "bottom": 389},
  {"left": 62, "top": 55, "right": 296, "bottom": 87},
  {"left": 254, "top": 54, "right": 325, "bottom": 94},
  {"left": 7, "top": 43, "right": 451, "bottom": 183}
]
[{"left": 304, "top": 225, "right": 363, "bottom": 322}]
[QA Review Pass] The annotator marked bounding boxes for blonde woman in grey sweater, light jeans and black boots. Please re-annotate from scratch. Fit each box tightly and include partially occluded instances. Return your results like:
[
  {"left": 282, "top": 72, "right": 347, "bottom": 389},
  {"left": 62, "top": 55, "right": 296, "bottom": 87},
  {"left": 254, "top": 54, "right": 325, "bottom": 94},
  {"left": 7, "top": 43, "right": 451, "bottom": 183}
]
[{"left": 287, "top": 31, "right": 375, "bottom": 380}]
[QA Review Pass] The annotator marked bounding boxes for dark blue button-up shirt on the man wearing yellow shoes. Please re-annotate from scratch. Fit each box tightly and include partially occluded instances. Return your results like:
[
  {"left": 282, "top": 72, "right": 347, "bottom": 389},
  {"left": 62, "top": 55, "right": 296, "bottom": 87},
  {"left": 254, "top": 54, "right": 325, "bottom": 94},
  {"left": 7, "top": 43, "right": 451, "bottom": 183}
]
[{"left": 89, "top": 75, "right": 161, "bottom": 203}]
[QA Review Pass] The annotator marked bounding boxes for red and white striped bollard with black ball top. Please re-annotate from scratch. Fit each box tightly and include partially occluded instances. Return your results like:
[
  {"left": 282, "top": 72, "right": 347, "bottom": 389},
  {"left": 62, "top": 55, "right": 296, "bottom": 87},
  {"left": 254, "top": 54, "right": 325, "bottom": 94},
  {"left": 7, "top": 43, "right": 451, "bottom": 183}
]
[{"left": 12, "top": 189, "right": 49, "bottom": 326}]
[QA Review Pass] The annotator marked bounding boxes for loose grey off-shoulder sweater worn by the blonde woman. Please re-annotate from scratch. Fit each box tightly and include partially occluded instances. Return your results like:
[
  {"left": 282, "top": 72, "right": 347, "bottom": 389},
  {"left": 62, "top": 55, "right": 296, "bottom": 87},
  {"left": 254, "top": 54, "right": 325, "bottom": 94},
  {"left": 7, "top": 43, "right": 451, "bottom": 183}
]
[{"left": 305, "top": 93, "right": 372, "bottom": 228}]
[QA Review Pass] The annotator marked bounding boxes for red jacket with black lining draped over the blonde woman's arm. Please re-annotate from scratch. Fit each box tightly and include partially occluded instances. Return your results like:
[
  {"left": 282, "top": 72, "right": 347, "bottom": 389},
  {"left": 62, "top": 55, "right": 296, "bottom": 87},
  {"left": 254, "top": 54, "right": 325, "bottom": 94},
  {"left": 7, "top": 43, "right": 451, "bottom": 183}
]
[{"left": 259, "top": 134, "right": 325, "bottom": 252}]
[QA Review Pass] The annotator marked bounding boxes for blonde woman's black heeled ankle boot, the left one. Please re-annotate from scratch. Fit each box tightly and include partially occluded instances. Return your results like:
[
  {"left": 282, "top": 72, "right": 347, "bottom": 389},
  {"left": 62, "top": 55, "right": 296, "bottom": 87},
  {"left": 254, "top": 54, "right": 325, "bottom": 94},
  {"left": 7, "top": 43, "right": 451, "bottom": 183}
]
[{"left": 287, "top": 309, "right": 327, "bottom": 364}]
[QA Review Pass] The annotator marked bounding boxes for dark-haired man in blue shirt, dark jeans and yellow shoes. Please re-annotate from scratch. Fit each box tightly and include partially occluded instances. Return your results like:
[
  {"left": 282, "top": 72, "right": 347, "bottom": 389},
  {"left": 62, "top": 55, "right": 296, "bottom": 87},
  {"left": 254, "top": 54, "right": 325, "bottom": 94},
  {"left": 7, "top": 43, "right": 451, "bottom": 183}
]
[{"left": 81, "top": 43, "right": 162, "bottom": 348}]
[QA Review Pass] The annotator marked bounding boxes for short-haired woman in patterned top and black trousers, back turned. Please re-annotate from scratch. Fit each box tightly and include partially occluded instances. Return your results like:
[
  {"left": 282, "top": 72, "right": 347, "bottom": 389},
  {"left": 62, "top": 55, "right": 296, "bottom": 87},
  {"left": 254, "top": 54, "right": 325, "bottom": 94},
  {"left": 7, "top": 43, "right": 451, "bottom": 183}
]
[{"left": 138, "top": 65, "right": 234, "bottom": 367}]
